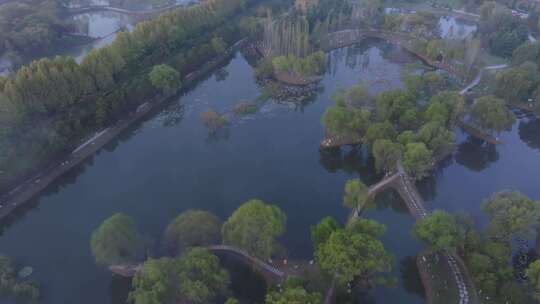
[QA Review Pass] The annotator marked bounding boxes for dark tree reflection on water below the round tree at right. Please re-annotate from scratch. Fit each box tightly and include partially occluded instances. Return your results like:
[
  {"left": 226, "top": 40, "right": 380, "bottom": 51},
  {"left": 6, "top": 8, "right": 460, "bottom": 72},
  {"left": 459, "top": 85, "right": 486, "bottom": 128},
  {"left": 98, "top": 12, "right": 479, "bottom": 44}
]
[{"left": 455, "top": 136, "right": 499, "bottom": 171}]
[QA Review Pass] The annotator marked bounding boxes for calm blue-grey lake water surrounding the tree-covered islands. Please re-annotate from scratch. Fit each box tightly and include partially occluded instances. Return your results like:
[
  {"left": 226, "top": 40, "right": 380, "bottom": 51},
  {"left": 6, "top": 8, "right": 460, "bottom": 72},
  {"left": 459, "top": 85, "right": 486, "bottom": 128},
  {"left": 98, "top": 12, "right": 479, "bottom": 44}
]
[{"left": 0, "top": 42, "right": 540, "bottom": 304}]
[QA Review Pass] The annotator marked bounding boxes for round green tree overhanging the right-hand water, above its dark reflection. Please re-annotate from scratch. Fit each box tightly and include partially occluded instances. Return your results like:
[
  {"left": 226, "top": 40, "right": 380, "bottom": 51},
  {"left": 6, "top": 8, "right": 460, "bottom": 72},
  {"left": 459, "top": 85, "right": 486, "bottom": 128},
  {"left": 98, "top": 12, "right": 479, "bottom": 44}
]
[{"left": 471, "top": 96, "right": 516, "bottom": 133}]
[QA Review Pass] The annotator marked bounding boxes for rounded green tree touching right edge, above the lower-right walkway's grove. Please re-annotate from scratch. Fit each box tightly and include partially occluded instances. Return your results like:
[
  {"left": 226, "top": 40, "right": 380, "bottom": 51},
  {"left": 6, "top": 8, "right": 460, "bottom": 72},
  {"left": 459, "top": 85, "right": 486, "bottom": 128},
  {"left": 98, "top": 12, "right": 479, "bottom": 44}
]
[{"left": 482, "top": 192, "right": 540, "bottom": 240}]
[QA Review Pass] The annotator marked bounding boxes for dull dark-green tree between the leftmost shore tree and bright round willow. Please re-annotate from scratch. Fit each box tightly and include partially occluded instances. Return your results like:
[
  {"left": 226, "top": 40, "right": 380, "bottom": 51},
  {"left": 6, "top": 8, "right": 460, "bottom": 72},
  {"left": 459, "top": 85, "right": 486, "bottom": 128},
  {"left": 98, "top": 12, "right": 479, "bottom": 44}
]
[{"left": 163, "top": 210, "right": 221, "bottom": 255}]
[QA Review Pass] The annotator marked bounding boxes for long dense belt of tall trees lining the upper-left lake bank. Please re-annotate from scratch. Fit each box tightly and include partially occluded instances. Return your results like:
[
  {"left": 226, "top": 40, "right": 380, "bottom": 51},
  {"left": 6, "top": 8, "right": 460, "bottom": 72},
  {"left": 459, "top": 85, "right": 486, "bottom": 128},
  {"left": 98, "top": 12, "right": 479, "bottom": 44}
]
[{"left": 0, "top": 0, "right": 268, "bottom": 190}]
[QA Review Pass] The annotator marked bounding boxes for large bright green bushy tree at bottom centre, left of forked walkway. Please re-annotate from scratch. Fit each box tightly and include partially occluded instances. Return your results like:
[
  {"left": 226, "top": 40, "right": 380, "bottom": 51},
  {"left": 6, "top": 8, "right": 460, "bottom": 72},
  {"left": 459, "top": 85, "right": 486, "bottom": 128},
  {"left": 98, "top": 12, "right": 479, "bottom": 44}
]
[{"left": 315, "top": 219, "right": 392, "bottom": 285}]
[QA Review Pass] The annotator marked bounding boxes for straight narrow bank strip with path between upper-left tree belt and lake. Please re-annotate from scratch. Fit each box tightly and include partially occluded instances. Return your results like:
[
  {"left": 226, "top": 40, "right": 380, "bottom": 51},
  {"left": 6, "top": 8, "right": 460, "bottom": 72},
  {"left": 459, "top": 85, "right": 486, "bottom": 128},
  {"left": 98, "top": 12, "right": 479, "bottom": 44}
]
[{"left": 0, "top": 38, "right": 248, "bottom": 221}]
